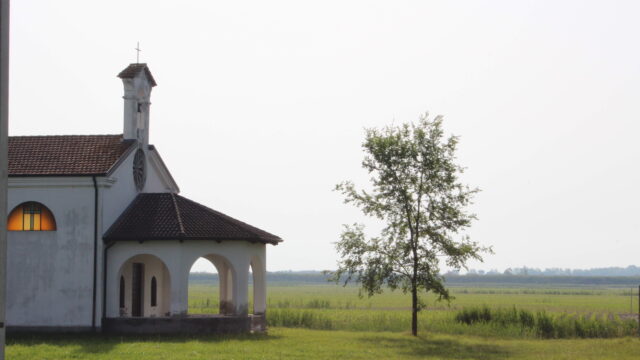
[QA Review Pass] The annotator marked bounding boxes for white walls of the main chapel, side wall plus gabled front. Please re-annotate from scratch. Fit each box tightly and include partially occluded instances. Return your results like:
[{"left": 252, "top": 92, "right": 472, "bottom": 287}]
[{"left": 6, "top": 142, "right": 180, "bottom": 326}]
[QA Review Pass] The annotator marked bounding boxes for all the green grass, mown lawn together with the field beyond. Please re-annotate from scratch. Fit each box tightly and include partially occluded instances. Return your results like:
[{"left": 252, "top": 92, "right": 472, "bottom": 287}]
[{"left": 7, "top": 284, "right": 640, "bottom": 360}]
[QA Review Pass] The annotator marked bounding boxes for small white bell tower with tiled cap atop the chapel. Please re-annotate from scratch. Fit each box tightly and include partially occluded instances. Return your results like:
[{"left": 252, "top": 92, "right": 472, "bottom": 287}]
[{"left": 118, "top": 64, "right": 156, "bottom": 145}]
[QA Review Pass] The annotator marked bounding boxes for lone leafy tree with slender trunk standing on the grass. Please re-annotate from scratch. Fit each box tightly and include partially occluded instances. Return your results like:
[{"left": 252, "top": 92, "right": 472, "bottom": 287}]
[{"left": 332, "top": 114, "right": 491, "bottom": 336}]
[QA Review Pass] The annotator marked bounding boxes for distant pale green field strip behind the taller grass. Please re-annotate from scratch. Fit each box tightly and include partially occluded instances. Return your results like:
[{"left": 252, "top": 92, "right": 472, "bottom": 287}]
[{"left": 189, "top": 284, "right": 638, "bottom": 313}]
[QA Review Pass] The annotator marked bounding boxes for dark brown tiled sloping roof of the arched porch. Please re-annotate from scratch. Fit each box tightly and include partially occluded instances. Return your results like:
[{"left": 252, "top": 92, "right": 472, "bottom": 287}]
[{"left": 103, "top": 193, "right": 282, "bottom": 245}]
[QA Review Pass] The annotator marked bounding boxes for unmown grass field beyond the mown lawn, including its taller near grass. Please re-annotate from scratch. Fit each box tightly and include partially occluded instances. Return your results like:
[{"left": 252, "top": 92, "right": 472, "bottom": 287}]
[{"left": 189, "top": 284, "right": 637, "bottom": 338}]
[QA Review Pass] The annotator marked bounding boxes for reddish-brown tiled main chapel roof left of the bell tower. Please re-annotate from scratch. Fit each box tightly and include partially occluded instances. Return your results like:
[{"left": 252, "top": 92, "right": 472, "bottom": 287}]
[{"left": 9, "top": 135, "right": 136, "bottom": 176}]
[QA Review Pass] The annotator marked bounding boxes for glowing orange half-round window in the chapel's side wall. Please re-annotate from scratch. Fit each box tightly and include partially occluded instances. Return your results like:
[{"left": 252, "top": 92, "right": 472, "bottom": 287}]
[{"left": 7, "top": 201, "right": 56, "bottom": 231}]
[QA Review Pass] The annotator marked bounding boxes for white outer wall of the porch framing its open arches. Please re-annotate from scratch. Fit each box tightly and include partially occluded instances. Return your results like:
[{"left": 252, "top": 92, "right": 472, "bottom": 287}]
[{"left": 107, "top": 240, "right": 266, "bottom": 317}]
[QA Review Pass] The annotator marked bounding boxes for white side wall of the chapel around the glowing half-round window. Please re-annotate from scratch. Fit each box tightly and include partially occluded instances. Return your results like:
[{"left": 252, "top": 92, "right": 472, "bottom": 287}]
[{"left": 7, "top": 178, "right": 94, "bottom": 326}]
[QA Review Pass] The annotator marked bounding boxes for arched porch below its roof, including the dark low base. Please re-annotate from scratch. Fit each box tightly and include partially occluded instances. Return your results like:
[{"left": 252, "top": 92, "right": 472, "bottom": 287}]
[{"left": 105, "top": 240, "right": 266, "bottom": 333}]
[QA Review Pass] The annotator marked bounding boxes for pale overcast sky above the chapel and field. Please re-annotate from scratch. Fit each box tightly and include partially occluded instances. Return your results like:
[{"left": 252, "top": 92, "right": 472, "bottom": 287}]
[{"left": 9, "top": 0, "right": 640, "bottom": 271}]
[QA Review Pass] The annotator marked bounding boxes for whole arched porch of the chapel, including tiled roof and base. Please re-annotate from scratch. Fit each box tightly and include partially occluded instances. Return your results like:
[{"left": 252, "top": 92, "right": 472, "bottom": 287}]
[{"left": 104, "top": 193, "right": 282, "bottom": 332}]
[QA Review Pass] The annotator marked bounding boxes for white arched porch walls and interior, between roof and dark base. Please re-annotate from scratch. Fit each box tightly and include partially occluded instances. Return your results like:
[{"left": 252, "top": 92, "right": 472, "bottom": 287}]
[{"left": 106, "top": 240, "right": 266, "bottom": 318}]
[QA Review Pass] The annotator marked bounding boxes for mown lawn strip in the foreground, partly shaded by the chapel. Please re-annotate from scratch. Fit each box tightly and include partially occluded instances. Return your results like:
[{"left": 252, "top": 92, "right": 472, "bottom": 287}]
[{"left": 7, "top": 328, "right": 640, "bottom": 360}]
